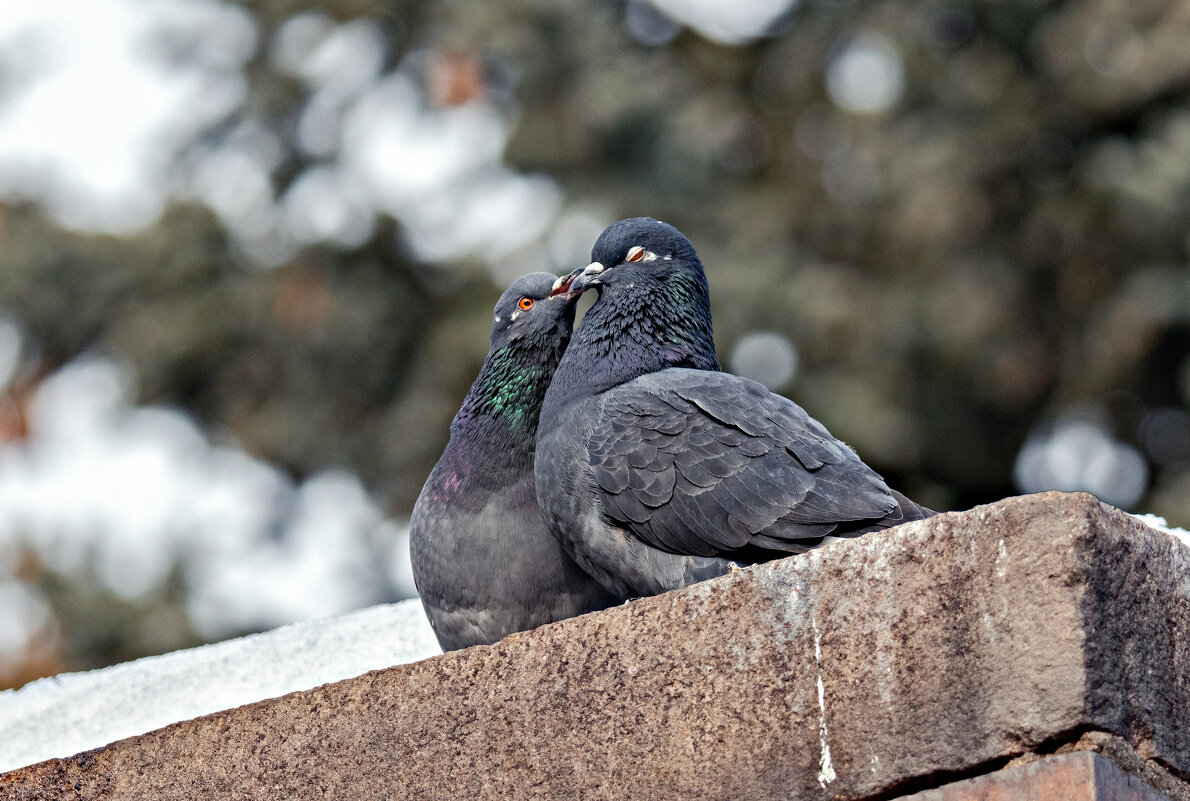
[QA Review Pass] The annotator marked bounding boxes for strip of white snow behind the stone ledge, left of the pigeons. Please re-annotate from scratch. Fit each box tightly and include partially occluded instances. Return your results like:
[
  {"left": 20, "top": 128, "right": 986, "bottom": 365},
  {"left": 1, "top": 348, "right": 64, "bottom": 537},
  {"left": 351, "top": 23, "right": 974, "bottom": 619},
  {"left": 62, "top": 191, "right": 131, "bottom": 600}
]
[{"left": 0, "top": 599, "right": 441, "bottom": 772}]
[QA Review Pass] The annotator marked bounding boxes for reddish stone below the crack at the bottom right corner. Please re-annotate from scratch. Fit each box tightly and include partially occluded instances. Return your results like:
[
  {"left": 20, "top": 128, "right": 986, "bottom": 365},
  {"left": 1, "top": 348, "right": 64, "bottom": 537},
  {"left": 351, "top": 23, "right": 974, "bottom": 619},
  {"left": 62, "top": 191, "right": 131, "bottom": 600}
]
[{"left": 904, "top": 752, "right": 1170, "bottom": 801}]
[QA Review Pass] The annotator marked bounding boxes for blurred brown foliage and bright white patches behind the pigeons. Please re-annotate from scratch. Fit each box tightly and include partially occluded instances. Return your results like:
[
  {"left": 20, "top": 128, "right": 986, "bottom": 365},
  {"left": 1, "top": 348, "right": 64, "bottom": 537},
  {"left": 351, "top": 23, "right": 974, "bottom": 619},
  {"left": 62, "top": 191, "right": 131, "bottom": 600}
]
[{"left": 0, "top": 0, "right": 1190, "bottom": 687}]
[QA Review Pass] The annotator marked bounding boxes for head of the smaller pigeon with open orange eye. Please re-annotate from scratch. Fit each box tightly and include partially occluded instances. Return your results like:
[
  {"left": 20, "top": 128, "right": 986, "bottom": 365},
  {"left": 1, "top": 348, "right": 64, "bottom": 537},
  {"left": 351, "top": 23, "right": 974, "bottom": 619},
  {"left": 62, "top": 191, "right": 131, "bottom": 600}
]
[{"left": 491, "top": 273, "right": 577, "bottom": 351}]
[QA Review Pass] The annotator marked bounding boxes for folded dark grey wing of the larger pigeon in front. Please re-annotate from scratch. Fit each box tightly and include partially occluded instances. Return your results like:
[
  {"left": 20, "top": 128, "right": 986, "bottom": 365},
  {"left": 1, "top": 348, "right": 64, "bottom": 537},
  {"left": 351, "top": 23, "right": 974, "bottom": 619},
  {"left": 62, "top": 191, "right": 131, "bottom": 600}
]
[{"left": 587, "top": 369, "right": 900, "bottom": 556}]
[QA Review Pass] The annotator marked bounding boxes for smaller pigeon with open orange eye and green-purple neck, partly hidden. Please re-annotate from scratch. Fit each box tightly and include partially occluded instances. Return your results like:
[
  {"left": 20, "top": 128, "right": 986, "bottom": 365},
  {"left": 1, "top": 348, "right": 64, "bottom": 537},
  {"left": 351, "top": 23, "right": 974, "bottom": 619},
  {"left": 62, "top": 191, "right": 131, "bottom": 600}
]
[{"left": 409, "top": 273, "right": 625, "bottom": 651}]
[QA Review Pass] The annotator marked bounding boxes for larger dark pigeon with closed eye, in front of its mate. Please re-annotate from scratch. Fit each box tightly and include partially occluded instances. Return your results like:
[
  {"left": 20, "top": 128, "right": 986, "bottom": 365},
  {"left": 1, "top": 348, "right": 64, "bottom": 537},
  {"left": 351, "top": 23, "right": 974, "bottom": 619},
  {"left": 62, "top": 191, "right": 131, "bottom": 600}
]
[{"left": 536, "top": 218, "right": 933, "bottom": 596}]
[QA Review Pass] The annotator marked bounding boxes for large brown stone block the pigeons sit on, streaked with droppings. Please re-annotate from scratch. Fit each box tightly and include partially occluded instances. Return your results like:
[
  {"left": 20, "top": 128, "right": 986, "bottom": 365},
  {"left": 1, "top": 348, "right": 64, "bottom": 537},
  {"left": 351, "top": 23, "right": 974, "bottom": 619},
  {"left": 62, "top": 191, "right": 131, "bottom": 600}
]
[{"left": 0, "top": 493, "right": 1190, "bottom": 800}]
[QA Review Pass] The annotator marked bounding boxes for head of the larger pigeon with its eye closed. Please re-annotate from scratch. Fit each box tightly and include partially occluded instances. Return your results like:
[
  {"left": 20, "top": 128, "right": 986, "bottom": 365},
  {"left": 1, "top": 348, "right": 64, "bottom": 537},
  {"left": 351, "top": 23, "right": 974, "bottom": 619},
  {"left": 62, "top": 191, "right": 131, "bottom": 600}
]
[{"left": 556, "top": 217, "right": 702, "bottom": 298}]
